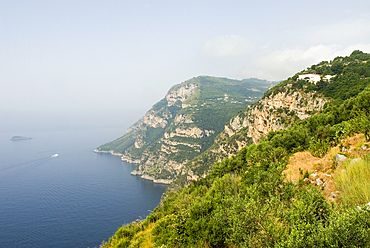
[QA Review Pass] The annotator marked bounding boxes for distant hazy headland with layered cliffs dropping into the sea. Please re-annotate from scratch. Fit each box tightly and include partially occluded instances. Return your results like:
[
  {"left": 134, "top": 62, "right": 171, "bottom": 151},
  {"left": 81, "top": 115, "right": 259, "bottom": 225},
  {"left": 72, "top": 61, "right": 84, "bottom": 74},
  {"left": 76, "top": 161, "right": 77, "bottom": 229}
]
[{"left": 95, "top": 77, "right": 272, "bottom": 184}]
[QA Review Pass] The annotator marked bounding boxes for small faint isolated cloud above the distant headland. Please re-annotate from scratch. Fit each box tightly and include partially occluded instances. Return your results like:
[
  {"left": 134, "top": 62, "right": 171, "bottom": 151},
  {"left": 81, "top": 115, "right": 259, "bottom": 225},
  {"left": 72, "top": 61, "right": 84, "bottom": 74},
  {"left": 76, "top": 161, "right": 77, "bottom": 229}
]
[{"left": 202, "top": 35, "right": 252, "bottom": 57}]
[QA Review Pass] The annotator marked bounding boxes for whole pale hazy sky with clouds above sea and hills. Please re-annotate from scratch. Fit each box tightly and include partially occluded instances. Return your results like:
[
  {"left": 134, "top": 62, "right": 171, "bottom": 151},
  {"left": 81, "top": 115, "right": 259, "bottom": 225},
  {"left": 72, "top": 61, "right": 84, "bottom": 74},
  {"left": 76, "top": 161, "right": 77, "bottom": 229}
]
[{"left": 0, "top": 0, "right": 370, "bottom": 130}]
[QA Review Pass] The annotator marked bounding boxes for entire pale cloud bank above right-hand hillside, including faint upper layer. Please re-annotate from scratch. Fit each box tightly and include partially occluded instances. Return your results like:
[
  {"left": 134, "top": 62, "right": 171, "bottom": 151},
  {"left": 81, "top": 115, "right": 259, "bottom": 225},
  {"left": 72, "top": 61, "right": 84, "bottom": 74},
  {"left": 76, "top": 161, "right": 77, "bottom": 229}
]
[{"left": 243, "top": 14, "right": 370, "bottom": 80}]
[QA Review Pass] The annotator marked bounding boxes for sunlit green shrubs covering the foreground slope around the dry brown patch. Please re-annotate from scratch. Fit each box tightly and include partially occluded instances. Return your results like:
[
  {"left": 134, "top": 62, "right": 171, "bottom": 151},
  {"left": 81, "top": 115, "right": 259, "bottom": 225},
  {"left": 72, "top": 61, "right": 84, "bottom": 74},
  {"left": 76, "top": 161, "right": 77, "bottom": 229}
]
[{"left": 103, "top": 52, "right": 370, "bottom": 247}]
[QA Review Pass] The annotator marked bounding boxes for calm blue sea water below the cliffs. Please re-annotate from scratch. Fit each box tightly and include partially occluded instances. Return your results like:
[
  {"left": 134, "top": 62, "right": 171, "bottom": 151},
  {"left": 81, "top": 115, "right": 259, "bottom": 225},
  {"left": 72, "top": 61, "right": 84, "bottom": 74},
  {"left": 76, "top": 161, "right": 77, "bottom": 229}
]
[{"left": 0, "top": 128, "right": 166, "bottom": 248}]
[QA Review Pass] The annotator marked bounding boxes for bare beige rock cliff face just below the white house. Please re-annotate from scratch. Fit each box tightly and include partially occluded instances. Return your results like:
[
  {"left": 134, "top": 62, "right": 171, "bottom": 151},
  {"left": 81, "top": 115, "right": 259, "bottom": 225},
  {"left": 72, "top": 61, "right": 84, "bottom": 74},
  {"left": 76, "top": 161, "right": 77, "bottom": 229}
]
[{"left": 187, "top": 84, "right": 328, "bottom": 180}]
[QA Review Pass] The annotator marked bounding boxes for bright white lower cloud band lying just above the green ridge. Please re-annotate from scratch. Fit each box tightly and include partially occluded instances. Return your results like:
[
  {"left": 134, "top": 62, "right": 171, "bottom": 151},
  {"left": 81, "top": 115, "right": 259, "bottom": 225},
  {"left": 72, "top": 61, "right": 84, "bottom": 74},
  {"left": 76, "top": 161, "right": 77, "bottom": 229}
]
[{"left": 253, "top": 44, "right": 370, "bottom": 80}]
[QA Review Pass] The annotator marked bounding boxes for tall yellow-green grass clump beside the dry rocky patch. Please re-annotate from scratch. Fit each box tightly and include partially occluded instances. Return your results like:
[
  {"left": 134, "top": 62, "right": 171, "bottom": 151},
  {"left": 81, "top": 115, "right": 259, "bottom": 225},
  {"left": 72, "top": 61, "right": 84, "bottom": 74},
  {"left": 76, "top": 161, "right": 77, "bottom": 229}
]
[{"left": 335, "top": 159, "right": 370, "bottom": 207}]
